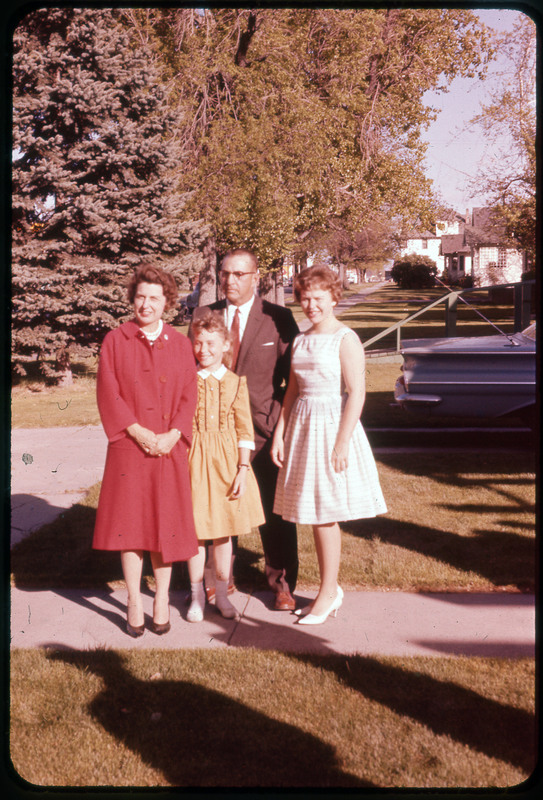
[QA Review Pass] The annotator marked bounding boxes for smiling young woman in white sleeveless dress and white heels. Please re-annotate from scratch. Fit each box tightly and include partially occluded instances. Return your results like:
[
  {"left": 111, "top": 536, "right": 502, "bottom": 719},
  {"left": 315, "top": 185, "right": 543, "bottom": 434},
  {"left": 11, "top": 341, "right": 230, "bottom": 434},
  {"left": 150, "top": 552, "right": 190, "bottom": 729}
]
[{"left": 271, "top": 266, "right": 386, "bottom": 625}]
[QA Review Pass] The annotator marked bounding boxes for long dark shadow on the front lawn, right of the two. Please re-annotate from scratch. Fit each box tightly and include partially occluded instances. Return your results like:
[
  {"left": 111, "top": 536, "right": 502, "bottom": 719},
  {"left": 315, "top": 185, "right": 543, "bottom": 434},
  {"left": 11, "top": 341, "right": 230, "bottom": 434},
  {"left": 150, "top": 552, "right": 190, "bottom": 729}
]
[{"left": 296, "top": 654, "right": 537, "bottom": 775}]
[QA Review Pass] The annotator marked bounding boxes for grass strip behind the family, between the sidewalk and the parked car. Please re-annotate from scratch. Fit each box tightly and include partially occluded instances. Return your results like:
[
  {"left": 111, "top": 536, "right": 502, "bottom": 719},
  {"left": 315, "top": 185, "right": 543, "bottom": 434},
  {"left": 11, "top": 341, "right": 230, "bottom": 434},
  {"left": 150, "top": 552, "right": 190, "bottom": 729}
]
[{"left": 11, "top": 451, "right": 535, "bottom": 591}]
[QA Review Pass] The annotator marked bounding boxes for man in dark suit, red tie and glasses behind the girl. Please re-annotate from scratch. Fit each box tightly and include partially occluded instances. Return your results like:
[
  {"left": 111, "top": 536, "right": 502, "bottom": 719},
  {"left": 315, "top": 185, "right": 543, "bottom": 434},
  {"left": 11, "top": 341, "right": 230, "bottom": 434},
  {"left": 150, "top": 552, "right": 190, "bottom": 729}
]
[{"left": 194, "top": 250, "right": 298, "bottom": 611}]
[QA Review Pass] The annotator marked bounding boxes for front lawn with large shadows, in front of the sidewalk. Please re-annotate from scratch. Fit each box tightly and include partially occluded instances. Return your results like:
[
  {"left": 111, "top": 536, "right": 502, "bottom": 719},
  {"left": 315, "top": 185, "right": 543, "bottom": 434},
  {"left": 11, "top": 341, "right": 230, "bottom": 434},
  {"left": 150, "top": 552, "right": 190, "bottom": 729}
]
[{"left": 11, "top": 649, "right": 535, "bottom": 789}]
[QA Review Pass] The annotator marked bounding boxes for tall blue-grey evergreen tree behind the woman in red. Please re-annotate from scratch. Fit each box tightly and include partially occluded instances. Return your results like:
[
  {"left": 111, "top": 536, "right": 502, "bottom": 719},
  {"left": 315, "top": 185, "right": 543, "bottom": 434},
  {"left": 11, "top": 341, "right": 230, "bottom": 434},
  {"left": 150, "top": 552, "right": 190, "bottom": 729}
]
[{"left": 13, "top": 8, "right": 203, "bottom": 379}]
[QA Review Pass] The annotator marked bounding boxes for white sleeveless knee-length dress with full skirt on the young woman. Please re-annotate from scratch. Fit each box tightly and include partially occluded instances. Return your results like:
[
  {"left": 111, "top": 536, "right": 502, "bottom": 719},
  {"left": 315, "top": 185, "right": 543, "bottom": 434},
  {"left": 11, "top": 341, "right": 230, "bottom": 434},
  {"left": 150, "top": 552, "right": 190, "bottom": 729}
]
[{"left": 274, "top": 326, "right": 387, "bottom": 525}]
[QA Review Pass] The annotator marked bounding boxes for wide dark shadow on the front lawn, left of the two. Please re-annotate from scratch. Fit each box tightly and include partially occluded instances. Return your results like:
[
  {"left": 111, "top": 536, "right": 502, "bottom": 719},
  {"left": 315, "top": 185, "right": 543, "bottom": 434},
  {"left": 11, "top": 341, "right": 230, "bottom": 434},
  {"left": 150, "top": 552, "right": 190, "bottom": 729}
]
[{"left": 46, "top": 651, "right": 371, "bottom": 788}]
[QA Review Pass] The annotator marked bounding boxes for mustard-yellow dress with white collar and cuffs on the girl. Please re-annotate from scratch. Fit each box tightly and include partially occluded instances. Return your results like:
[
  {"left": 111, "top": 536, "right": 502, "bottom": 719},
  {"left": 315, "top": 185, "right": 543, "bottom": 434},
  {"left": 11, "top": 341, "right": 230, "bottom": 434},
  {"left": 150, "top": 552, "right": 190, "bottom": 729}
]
[{"left": 189, "top": 367, "right": 265, "bottom": 541}]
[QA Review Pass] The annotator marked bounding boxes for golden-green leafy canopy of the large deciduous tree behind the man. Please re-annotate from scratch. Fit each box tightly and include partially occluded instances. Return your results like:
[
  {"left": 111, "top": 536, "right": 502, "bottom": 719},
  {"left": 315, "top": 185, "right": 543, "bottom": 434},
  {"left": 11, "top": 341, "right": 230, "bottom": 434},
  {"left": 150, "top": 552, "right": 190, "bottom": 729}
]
[{"left": 130, "top": 8, "right": 488, "bottom": 266}]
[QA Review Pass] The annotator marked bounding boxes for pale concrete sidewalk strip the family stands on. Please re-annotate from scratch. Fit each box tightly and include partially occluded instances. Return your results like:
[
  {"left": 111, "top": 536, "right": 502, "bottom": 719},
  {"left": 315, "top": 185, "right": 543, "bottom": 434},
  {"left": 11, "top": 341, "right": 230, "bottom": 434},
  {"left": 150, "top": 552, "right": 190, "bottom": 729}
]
[{"left": 11, "top": 589, "right": 535, "bottom": 658}]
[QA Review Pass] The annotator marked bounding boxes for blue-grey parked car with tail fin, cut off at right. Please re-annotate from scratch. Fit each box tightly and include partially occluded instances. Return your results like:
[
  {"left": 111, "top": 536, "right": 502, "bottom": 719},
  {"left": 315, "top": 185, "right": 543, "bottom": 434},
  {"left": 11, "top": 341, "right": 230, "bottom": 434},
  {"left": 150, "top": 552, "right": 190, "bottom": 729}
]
[{"left": 394, "top": 322, "right": 536, "bottom": 425}]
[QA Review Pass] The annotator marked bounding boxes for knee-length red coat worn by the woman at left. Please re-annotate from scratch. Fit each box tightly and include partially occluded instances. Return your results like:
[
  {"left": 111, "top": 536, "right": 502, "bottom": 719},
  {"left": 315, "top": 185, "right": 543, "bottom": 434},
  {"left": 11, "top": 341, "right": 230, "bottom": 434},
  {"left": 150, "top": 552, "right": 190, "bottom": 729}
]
[{"left": 93, "top": 321, "right": 198, "bottom": 562}]
